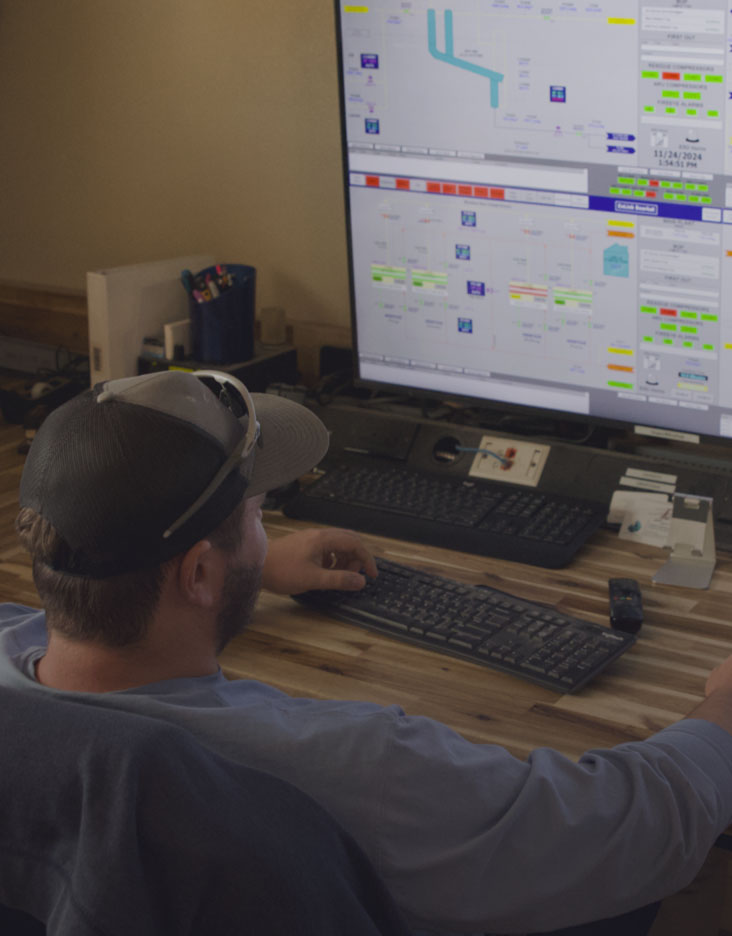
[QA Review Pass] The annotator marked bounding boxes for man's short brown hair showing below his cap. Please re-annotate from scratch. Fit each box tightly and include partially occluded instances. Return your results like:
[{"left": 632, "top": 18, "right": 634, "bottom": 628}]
[{"left": 15, "top": 499, "right": 244, "bottom": 647}]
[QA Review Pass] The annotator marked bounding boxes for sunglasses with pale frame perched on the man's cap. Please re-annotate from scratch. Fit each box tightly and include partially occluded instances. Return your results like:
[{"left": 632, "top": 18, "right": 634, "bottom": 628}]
[{"left": 163, "top": 370, "right": 261, "bottom": 539}]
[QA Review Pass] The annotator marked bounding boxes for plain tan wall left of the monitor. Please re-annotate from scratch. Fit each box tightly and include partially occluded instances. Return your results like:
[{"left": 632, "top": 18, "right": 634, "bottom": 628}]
[{"left": 0, "top": 0, "right": 348, "bottom": 325}]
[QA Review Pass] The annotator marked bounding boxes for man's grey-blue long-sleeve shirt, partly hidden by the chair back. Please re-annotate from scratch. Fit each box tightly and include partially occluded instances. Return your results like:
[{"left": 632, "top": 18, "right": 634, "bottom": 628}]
[{"left": 0, "top": 605, "right": 732, "bottom": 933}]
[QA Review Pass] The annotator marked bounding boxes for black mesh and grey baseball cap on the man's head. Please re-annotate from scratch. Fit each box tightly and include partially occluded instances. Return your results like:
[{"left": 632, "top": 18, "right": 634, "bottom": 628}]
[{"left": 20, "top": 371, "right": 328, "bottom": 578}]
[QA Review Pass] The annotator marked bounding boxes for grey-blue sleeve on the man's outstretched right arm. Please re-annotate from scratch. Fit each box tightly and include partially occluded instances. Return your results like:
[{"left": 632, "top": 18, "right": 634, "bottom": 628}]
[{"left": 379, "top": 716, "right": 732, "bottom": 932}]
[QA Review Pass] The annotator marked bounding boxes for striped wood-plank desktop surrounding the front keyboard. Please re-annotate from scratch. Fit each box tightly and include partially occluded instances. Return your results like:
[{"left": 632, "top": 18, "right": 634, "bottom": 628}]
[{"left": 221, "top": 513, "right": 732, "bottom": 758}]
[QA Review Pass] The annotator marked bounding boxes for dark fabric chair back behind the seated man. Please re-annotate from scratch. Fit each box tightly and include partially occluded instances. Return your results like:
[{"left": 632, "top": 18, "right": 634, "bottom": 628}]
[{"left": 0, "top": 688, "right": 407, "bottom": 936}]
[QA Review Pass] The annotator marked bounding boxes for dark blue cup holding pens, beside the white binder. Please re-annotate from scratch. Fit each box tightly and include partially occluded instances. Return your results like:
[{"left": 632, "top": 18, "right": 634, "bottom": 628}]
[{"left": 188, "top": 263, "right": 257, "bottom": 364}]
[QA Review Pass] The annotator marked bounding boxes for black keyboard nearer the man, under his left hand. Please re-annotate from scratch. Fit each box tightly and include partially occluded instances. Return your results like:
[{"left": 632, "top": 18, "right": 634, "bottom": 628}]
[{"left": 294, "top": 558, "right": 636, "bottom": 692}]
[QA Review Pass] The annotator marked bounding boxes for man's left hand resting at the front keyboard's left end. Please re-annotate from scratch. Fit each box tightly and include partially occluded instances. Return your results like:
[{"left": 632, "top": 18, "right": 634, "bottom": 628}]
[{"left": 262, "top": 529, "right": 378, "bottom": 595}]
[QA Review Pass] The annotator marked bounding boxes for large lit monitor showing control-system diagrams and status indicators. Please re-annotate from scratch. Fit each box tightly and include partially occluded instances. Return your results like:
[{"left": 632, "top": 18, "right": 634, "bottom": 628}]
[{"left": 336, "top": 0, "right": 732, "bottom": 438}]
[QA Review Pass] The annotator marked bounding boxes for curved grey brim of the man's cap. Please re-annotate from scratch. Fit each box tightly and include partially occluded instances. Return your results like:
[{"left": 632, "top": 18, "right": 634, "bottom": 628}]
[{"left": 246, "top": 393, "right": 330, "bottom": 497}]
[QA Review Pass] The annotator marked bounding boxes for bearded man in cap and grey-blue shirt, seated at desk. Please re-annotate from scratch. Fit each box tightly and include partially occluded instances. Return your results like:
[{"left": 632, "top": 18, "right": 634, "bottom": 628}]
[{"left": 0, "top": 372, "right": 732, "bottom": 936}]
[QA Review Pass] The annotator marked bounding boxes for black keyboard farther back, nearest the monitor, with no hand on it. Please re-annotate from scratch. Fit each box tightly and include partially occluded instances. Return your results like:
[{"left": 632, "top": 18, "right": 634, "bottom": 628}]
[{"left": 284, "top": 461, "right": 607, "bottom": 569}]
